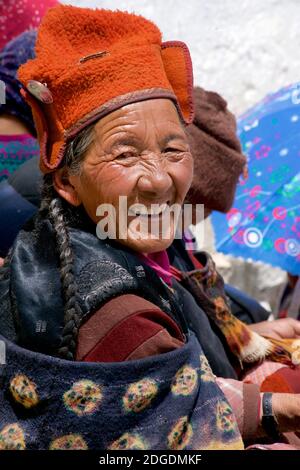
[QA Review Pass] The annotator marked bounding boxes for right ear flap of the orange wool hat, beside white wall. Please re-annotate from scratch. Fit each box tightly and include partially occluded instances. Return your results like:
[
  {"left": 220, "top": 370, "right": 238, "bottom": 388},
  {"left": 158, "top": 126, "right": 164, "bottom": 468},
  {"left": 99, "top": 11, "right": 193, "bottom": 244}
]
[{"left": 161, "top": 41, "right": 194, "bottom": 124}]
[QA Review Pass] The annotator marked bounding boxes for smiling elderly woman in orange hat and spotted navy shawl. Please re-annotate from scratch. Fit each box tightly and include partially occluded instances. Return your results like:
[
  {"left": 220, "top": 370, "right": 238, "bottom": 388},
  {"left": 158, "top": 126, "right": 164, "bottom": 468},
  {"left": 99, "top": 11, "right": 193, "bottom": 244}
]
[{"left": 0, "top": 6, "right": 300, "bottom": 449}]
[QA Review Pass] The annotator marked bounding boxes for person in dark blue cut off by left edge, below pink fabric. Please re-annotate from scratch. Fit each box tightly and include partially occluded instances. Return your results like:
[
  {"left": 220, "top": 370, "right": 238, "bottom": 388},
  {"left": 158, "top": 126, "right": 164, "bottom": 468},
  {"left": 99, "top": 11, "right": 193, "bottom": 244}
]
[{"left": 0, "top": 30, "right": 39, "bottom": 257}]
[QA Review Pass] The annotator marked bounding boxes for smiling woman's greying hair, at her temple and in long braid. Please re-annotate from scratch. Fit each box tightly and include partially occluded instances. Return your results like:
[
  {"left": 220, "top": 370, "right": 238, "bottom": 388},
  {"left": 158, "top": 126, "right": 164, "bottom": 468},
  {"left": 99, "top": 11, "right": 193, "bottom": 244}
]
[{"left": 40, "top": 125, "right": 94, "bottom": 360}]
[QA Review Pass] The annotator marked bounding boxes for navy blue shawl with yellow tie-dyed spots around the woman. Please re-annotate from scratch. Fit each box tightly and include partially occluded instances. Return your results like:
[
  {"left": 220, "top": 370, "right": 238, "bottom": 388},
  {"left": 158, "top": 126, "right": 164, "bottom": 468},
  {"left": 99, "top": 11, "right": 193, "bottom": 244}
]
[{"left": 0, "top": 335, "right": 243, "bottom": 450}]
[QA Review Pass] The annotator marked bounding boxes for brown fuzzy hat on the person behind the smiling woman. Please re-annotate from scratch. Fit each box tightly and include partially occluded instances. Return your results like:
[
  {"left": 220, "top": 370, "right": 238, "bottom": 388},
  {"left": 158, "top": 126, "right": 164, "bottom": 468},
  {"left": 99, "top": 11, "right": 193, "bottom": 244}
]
[{"left": 186, "top": 87, "right": 246, "bottom": 212}]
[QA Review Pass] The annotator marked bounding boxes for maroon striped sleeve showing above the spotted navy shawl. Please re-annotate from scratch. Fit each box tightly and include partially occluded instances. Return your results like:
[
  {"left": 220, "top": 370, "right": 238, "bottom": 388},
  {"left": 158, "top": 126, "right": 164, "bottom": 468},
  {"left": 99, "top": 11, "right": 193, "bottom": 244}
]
[{"left": 76, "top": 294, "right": 184, "bottom": 362}]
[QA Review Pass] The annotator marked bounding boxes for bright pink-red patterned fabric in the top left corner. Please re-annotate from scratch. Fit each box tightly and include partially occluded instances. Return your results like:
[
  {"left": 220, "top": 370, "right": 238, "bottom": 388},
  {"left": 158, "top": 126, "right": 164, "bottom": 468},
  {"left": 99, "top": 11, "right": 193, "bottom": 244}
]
[{"left": 0, "top": 0, "right": 59, "bottom": 49}]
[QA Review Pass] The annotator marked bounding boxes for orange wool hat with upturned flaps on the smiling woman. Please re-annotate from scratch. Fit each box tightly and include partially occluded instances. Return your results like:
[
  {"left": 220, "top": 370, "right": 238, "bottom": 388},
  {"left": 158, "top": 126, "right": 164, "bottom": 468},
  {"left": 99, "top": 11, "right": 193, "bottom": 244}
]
[{"left": 19, "top": 5, "right": 193, "bottom": 173}]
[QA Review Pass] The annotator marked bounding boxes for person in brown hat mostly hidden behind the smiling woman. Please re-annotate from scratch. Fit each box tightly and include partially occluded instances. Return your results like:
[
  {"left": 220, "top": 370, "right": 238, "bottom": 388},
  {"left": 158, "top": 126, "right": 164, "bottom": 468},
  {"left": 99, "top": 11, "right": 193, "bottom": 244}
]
[{"left": 168, "top": 87, "right": 300, "bottom": 339}]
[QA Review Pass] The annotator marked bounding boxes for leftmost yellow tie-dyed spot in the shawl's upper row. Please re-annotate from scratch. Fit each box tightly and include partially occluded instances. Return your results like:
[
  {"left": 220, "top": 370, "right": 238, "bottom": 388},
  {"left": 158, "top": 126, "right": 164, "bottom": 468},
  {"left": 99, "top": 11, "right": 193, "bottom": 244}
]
[{"left": 9, "top": 374, "right": 39, "bottom": 408}]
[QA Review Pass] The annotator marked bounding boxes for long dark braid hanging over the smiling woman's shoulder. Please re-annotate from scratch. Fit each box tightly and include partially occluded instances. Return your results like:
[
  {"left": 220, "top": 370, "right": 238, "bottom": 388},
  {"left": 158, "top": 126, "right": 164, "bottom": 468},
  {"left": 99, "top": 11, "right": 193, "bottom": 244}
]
[{"left": 40, "top": 175, "right": 82, "bottom": 360}]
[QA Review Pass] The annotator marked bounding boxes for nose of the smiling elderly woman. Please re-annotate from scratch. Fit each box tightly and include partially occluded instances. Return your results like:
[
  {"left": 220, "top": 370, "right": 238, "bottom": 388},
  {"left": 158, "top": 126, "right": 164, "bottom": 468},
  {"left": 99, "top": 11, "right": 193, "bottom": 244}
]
[{"left": 137, "top": 162, "right": 173, "bottom": 196}]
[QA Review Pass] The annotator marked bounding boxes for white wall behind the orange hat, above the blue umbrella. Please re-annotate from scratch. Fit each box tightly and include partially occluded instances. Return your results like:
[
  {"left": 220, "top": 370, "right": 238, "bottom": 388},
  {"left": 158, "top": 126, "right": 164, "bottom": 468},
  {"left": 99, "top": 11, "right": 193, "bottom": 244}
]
[{"left": 63, "top": 0, "right": 300, "bottom": 113}]
